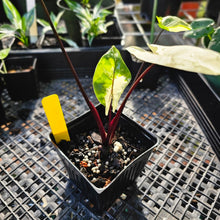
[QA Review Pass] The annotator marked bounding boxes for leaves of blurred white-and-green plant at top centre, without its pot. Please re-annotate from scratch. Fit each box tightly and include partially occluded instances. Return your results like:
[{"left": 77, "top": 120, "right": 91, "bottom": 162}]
[{"left": 65, "top": 0, "right": 113, "bottom": 46}]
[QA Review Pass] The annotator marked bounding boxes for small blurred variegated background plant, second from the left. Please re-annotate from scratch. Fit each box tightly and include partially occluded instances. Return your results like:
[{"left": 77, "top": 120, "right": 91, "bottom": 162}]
[{"left": 37, "top": 11, "right": 78, "bottom": 48}]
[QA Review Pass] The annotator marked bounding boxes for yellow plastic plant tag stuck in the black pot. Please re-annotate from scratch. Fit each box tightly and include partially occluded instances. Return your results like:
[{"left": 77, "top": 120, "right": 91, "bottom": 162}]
[{"left": 42, "top": 94, "right": 70, "bottom": 143}]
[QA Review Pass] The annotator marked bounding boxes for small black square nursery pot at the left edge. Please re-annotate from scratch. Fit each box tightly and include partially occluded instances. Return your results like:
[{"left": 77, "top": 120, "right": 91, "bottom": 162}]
[{"left": 1, "top": 56, "right": 39, "bottom": 101}]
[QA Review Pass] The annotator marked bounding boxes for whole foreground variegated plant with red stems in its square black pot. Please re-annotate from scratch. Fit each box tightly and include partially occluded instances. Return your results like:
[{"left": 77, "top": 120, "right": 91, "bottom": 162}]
[{"left": 41, "top": 0, "right": 220, "bottom": 212}]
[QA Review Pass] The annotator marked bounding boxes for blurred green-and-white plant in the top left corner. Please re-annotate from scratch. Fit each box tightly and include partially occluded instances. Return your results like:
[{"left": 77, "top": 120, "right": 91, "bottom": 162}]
[{"left": 0, "top": 0, "right": 35, "bottom": 47}]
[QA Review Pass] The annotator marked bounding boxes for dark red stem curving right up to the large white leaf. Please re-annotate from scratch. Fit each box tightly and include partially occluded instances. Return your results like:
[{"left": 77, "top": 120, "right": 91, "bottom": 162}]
[{"left": 107, "top": 64, "right": 154, "bottom": 145}]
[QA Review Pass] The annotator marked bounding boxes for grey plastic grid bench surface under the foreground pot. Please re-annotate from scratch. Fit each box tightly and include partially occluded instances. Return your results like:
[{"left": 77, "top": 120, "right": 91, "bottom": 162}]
[{"left": 0, "top": 75, "right": 220, "bottom": 220}]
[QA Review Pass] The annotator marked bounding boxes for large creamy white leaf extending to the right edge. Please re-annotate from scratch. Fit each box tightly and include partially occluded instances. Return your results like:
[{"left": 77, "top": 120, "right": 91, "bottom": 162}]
[{"left": 127, "top": 44, "right": 220, "bottom": 75}]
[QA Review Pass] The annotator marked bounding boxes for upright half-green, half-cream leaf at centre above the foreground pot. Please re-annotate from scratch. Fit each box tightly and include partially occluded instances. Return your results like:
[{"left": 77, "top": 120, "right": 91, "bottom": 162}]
[{"left": 93, "top": 46, "right": 131, "bottom": 115}]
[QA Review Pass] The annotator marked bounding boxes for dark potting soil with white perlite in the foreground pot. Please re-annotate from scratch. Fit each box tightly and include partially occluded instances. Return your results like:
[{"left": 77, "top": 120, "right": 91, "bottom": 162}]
[{"left": 59, "top": 130, "right": 144, "bottom": 188}]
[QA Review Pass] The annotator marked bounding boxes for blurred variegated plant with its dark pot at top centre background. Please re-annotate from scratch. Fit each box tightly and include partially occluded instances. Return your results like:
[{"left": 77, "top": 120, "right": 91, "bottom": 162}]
[{"left": 58, "top": 0, "right": 122, "bottom": 46}]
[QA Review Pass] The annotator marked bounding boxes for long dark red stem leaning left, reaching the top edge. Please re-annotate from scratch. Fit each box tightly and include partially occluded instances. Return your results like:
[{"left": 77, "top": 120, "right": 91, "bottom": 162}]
[{"left": 41, "top": 0, "right": 106, "bottom": 143}]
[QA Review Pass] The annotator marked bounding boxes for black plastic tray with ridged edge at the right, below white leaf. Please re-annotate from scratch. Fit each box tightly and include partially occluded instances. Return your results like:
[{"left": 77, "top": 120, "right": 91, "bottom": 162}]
[{"left": 177, "top": 71, "right": 220, "bottom": 160}]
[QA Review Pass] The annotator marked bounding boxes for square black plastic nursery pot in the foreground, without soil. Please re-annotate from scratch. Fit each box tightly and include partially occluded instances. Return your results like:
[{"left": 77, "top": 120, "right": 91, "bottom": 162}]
[{"left": 50, "top": 105, "right": 158, "bottom": 214}]
